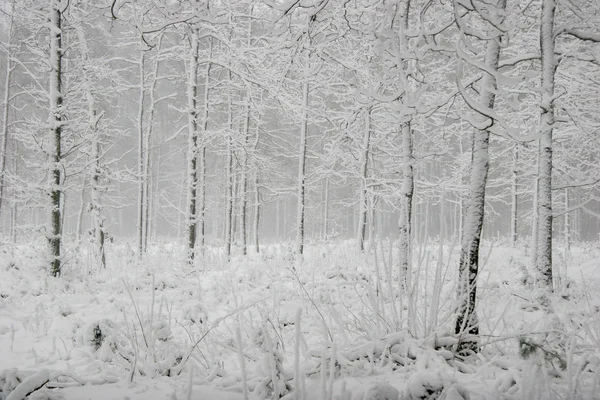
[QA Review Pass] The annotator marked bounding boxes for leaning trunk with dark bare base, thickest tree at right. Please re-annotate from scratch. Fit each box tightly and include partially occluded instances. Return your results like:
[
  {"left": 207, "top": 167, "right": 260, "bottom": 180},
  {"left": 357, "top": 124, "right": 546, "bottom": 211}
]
[{"left": 455, "top": 0, "right": 506, "bottom": 352}]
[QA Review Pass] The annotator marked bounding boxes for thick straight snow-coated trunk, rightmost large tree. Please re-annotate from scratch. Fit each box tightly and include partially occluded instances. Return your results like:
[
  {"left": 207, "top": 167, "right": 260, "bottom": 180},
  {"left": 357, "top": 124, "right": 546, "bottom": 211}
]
[{"left": 536, "top": 0, "right": 557, "bottom": 291}]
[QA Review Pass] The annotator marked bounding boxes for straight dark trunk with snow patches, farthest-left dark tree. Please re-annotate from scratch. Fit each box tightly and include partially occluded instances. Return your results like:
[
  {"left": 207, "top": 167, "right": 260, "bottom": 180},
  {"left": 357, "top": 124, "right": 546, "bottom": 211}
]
[{"left": 48, "top": 0, "right": 63, "bottom": 277}]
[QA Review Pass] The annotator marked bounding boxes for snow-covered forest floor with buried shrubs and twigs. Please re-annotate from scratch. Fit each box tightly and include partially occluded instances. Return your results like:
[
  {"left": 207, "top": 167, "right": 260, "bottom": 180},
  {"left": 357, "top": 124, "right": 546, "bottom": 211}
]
[{"left": 0, "top": 242, "right": 600, "bottom": 400}]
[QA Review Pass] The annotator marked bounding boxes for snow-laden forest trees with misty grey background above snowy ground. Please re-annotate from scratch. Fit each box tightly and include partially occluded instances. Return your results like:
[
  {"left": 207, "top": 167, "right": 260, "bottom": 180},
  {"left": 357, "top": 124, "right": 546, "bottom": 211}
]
[{"left": 0, "top": 0, "right": 600, "bottom": 350}]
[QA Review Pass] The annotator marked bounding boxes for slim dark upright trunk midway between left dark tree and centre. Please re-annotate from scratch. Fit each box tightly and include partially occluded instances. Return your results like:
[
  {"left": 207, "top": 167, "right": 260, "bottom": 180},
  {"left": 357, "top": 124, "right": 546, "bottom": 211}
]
[{"left": 187, "top": 29, "right": 199, "bottom": 265}]
